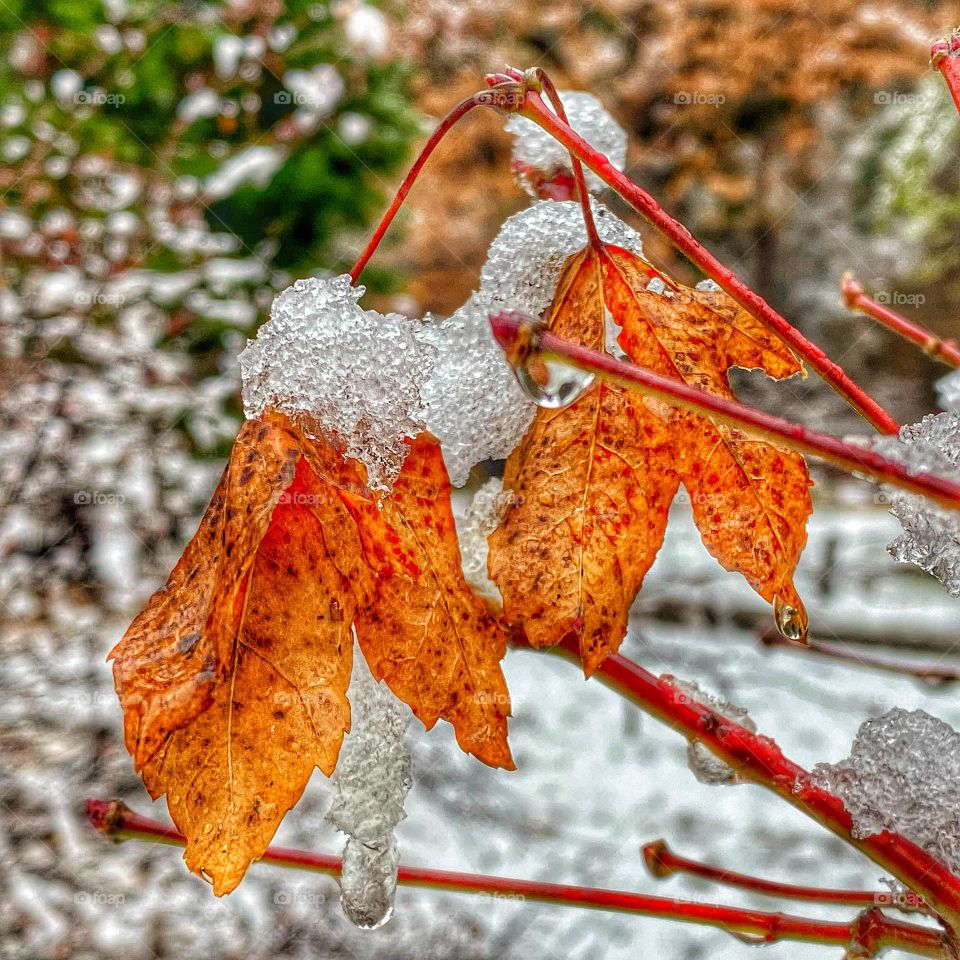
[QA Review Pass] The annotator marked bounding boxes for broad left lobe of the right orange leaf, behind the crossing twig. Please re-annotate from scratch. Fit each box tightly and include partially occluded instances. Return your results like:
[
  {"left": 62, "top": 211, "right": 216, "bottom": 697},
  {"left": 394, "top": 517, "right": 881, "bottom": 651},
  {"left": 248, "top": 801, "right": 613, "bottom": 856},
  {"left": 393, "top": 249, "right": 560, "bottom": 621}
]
[{"left": 489, "top": 251, "right": 679, "bottom": 674}]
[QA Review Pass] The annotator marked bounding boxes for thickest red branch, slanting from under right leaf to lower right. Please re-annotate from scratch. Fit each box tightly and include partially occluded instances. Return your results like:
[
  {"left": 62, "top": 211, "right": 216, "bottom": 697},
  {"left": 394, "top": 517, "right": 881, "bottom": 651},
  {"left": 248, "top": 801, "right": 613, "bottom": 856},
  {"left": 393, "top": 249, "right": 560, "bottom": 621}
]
[{"left": 515, "top": 639, "right": 960, "bottom": 930}]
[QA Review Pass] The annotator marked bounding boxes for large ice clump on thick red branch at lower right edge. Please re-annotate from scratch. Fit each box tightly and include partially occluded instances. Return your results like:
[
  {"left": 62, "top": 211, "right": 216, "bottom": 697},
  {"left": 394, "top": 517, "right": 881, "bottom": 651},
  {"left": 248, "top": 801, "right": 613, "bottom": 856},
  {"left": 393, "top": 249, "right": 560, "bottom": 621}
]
[{"left": 811, "top": 708, "right": 960, "bottom": 874}]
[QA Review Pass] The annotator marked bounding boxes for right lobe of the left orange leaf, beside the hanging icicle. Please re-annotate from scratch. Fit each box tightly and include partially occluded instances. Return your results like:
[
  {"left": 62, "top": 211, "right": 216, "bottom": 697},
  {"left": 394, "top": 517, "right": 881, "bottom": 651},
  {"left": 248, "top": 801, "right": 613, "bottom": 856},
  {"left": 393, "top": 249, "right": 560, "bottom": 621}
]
[{"left": 339, "top": 434, "right": 514, "bottom": 770}]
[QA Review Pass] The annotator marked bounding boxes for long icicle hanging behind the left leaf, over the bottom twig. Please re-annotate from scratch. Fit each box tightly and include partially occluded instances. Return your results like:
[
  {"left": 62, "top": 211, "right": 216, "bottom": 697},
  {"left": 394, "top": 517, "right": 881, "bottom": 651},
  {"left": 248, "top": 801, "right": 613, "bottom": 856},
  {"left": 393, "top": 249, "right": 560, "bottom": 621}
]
[{"left": 327, "top": 647, "right": 413, "bottom": 928}]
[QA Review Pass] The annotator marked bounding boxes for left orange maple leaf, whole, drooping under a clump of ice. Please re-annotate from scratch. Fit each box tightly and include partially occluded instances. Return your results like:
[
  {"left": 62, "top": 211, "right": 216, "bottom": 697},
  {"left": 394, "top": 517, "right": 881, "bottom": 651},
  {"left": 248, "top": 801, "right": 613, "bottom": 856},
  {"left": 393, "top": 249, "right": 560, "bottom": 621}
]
[{"left": 110, "top": 411, "right": 513, "bottom": 895}]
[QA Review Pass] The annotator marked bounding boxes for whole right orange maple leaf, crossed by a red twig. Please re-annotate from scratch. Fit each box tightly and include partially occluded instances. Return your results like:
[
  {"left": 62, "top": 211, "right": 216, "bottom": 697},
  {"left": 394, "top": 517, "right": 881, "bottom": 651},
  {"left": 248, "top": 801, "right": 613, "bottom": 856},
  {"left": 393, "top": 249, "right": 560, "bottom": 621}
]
[{"left": 489, "top": 247, "right": 811, "bottom": 675}]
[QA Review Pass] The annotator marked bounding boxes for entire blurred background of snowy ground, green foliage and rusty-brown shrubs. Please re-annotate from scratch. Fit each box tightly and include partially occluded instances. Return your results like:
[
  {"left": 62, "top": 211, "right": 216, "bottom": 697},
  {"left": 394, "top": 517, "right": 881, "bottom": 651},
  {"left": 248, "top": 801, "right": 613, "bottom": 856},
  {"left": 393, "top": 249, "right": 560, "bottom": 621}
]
[{"left": 0, "top": 0, "right": 960, "bottom": 960}]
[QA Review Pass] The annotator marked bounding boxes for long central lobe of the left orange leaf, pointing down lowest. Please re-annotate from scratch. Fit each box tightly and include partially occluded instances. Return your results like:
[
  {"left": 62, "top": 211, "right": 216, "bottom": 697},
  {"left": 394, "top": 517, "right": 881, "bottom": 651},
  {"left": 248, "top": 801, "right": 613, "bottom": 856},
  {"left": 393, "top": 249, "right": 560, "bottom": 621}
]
[{"left": 143, "top": 460, "right": 353, "bottom": 895}]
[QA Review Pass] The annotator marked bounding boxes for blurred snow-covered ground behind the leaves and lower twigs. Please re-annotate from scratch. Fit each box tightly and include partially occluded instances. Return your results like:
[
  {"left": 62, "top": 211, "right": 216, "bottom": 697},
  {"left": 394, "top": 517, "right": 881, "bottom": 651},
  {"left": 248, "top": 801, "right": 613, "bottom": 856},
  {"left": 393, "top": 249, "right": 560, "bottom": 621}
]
[{"left": 0, "top": 497, "right": 960, "bottom": 960}]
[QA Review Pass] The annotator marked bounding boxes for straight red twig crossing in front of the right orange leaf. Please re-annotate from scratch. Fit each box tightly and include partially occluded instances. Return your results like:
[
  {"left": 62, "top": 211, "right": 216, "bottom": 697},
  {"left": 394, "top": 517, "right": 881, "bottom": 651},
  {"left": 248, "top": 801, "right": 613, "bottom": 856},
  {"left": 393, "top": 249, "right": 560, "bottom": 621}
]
[{"left": 490, "top": 310, "right": 960, "bottom": 510}]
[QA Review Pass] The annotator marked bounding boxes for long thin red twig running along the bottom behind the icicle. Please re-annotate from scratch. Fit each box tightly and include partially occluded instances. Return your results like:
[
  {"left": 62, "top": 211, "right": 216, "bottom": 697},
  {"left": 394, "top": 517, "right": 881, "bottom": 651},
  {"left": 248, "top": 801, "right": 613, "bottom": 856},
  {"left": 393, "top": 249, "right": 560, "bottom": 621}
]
[{"left": 86, "top": 800, "right": 948, "bottom": 958}]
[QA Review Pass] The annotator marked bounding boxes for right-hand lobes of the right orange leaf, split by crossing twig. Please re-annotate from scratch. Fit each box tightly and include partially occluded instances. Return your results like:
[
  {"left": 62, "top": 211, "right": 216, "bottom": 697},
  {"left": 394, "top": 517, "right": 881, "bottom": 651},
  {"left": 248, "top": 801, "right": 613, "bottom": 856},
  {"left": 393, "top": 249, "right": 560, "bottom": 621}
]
[{"left": 604, "top": 248, "right": 812, "bottom": 633}]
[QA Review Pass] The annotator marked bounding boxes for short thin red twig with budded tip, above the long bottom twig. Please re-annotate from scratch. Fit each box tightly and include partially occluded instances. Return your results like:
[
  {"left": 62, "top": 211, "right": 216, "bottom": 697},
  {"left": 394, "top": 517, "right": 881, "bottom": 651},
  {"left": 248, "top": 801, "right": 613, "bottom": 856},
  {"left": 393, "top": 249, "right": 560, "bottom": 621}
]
[{"left": 642, "top": 840, "right": 927, "bottom": 913}]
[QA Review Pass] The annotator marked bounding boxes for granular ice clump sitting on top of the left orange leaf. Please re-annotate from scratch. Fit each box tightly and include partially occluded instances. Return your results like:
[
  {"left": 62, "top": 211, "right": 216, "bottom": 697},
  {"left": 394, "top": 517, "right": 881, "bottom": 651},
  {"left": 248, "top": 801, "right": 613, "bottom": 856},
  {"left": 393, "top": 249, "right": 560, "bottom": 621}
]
[{"left": 240, "top": 275, "right": 436, "bottom": 489}]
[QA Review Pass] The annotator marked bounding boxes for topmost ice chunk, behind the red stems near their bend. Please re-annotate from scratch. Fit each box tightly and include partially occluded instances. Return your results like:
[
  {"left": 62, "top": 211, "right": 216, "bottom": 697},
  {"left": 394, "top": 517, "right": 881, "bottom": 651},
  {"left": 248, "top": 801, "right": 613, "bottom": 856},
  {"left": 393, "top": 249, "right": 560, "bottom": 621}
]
[{"left": 506, "top": 90, "right": 627, "bottom": 193}]
